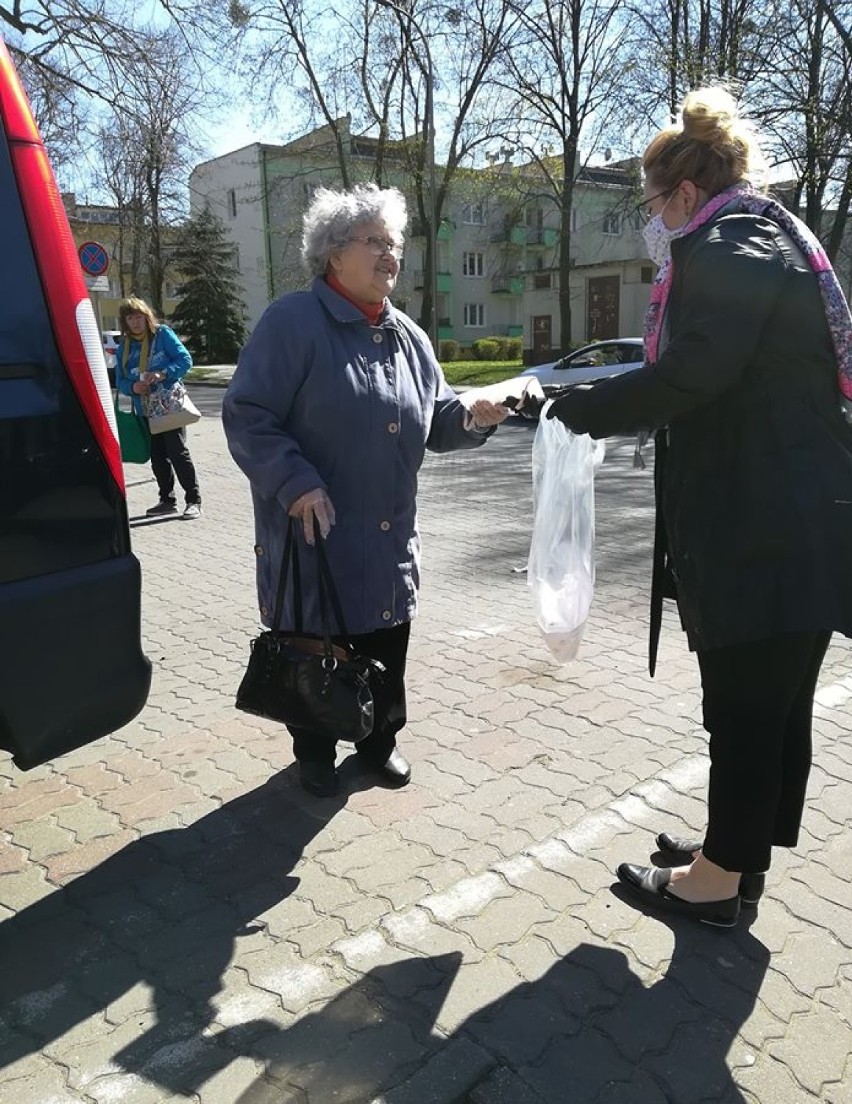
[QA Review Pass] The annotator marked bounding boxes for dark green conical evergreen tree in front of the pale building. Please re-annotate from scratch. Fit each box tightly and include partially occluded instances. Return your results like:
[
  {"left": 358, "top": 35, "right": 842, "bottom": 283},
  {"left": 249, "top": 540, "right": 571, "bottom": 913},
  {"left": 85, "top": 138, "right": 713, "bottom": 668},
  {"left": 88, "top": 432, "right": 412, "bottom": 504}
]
[{"left": 171, "top": 204, "right": 245, "bottom": 364}]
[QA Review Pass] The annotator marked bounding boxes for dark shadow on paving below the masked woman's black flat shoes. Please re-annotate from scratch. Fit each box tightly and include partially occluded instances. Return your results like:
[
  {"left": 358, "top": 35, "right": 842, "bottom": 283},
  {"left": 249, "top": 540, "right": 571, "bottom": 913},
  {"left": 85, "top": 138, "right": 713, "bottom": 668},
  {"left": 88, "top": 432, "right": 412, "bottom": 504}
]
[{"left": 228, "top": 900, "right": 769, "bottom": 1104}]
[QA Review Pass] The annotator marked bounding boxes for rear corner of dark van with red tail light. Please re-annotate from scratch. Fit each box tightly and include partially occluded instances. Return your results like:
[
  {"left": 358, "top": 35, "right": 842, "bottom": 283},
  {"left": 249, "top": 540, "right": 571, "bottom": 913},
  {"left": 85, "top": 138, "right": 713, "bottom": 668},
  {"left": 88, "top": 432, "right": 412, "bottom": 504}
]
[{"left": 0, "top": 42, "right": 151, "bottom": 769}]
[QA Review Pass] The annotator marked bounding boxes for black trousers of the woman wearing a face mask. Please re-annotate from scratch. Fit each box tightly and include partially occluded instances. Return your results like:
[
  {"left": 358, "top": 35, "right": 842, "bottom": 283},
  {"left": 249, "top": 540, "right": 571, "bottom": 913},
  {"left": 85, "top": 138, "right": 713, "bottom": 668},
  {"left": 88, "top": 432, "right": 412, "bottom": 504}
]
[{"left": 699, "top": 633, "right": 831, "bottom": 873}]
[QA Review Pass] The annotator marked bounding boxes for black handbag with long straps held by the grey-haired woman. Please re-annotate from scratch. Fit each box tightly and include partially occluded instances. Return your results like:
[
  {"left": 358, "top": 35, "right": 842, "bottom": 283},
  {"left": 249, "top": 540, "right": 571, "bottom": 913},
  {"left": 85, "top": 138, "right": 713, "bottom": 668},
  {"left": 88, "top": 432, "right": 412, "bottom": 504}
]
[{"left": 231, "top": 518, "right": 384, "bottom": 743}]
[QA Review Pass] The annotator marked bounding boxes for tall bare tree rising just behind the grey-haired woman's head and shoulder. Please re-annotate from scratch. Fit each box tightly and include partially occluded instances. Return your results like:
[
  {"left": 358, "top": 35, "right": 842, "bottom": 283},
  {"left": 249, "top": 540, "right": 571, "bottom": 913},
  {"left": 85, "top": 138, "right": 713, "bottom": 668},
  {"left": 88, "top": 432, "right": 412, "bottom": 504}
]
[{"left": 232, "top": 0, "right": 513, "bottom": 330}]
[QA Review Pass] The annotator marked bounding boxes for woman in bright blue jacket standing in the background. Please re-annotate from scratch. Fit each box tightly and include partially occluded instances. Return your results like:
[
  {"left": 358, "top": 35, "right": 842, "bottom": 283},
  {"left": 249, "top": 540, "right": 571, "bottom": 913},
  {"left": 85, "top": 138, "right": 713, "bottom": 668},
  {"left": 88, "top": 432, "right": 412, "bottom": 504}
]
[{"left": 116, "top": 298, "right": 201, "bottom": 521}]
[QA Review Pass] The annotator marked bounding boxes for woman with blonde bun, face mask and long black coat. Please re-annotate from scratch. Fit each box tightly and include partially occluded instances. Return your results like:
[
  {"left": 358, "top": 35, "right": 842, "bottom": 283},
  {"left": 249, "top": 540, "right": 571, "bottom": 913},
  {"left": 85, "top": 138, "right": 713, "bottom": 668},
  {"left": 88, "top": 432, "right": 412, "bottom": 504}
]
[{"left": 549, "top": 88, "right": 852, "bottom": 926}]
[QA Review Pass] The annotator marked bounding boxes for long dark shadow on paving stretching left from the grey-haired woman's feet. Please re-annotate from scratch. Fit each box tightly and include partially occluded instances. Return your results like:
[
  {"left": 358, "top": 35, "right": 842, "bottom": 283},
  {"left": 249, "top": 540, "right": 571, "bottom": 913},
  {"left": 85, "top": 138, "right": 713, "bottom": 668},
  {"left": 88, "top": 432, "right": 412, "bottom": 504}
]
[{"left": 0, "top": 768, "right": 366, "bottom": 1085}]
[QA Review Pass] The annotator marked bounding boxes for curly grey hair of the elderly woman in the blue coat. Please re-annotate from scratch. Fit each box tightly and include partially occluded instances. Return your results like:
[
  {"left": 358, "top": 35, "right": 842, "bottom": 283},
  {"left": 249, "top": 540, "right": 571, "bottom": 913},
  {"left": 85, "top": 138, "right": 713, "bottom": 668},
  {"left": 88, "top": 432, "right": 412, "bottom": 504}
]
[{"left": 301, "top": 184, "right": 408, "bottom": 276}]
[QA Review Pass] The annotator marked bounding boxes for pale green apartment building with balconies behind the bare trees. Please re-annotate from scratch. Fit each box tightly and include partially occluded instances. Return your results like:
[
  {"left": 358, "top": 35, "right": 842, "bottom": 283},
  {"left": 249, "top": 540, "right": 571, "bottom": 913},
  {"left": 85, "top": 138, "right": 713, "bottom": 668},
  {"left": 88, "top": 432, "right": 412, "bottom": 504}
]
[{"left": 190, "top": 119, "right": 652, "bottom": 359}]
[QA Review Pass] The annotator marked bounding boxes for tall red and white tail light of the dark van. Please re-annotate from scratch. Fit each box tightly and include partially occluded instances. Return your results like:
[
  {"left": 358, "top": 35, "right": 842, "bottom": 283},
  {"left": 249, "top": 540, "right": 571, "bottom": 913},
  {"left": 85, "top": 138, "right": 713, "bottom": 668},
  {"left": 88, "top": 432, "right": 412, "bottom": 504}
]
[{"left": 0, "top": 40, "right": 125, "bottom": 491}]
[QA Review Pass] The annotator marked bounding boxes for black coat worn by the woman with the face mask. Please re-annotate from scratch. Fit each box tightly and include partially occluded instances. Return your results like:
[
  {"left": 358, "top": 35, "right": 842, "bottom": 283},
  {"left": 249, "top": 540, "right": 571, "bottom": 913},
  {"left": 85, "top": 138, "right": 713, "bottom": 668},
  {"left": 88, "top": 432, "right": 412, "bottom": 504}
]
[{"left": 565, "top": 214, "right": 852, "bottom": 650}]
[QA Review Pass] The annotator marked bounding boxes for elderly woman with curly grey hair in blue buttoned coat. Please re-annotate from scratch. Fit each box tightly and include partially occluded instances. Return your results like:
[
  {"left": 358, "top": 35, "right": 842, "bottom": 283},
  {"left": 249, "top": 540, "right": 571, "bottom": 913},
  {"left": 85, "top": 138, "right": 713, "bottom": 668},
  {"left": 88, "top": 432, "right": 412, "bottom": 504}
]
[{"left": 223, "top": 184, "right": 508, "bottom": 796}]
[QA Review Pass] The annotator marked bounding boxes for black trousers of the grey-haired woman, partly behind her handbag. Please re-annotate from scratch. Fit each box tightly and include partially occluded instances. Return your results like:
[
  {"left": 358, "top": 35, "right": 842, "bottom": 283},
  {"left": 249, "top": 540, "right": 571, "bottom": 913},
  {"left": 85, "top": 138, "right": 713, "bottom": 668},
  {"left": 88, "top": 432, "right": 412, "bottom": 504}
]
[{"left": 287, "top": 622, "right": 412, "bottom": 766}]
